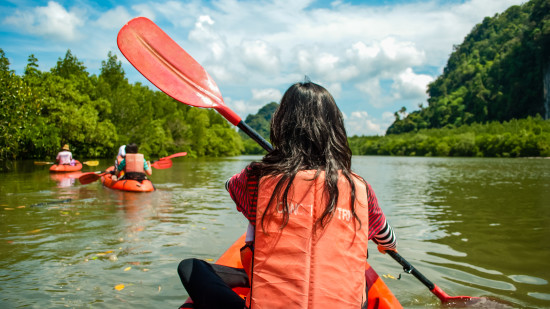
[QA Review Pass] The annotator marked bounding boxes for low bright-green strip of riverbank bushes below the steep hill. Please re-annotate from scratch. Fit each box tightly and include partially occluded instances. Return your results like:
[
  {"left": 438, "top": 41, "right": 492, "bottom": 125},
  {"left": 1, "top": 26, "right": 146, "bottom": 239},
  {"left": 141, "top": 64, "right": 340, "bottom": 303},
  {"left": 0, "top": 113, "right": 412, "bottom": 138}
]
[{"left": 349, "top": 116, "right": 550, "bottom": 157}]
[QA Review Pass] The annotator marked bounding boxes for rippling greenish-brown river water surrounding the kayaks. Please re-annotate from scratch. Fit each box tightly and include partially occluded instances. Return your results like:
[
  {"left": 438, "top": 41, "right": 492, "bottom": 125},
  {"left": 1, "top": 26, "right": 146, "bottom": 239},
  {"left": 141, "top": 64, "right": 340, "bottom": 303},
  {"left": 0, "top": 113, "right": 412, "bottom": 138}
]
[{"left": 0, "top": 156, "right": 550, "bottom": 308}]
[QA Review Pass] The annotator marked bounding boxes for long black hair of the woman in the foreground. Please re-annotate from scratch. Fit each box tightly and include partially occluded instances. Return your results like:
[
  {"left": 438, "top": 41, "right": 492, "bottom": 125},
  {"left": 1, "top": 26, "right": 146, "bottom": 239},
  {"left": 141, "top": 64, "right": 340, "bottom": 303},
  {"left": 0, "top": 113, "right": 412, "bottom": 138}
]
[{"left": 251, "top": 81, "right": 361, "bottom": 228}]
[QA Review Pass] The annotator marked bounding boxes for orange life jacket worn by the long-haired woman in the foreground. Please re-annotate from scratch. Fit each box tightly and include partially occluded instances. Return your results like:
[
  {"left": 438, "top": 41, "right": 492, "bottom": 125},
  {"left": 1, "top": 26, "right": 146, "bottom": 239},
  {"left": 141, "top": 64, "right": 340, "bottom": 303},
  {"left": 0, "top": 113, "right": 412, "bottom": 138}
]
[{"left": 249, "top": 171, "right": 368, "bottom": 309}]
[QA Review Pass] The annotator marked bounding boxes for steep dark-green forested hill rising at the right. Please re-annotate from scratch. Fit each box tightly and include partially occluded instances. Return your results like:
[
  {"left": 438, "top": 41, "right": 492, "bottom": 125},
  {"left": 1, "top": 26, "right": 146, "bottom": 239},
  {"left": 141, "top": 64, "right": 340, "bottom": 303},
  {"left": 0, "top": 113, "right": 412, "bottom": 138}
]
[{"left": 386, "top": 0, "right": 550, "bottom": 135}]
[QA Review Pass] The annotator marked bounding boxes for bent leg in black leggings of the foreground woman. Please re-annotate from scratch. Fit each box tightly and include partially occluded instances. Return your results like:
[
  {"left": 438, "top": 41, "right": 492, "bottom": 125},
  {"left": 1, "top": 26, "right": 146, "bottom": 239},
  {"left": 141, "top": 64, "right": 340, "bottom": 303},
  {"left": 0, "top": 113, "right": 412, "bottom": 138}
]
[{"left": 178, "top": 258, "right": 250, "bottom": 309}]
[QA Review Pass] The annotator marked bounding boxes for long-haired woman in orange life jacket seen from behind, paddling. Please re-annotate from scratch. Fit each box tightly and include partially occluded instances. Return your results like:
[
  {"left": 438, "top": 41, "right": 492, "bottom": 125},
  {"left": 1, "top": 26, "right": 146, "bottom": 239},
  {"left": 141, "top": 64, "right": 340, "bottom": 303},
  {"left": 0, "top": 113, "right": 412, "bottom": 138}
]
[{"left": 178, "top": 81, "right": 396, "bottom": 308}]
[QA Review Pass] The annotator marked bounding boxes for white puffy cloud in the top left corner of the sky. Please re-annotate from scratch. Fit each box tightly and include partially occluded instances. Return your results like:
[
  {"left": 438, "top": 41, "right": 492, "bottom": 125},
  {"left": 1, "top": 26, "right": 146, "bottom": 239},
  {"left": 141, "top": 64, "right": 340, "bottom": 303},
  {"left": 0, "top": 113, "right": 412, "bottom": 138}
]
[{"left": 4, "top": 1, "right": 85, "bottom": 41}]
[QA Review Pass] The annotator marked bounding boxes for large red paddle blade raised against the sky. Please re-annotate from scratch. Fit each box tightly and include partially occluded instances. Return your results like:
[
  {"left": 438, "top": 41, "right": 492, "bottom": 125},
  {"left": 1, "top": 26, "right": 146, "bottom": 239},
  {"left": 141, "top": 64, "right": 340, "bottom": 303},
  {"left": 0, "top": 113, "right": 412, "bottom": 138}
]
[{"left": 117, "top": 17, "right": 241, "bottom": 125}]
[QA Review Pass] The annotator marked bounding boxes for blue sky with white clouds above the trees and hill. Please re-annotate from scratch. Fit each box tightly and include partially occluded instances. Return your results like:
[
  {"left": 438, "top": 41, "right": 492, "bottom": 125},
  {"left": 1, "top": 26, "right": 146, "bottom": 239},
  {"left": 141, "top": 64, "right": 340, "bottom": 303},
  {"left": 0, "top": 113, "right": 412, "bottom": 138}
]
[{"left": 0, "top": 0, "right": 525, "bottom": 135}]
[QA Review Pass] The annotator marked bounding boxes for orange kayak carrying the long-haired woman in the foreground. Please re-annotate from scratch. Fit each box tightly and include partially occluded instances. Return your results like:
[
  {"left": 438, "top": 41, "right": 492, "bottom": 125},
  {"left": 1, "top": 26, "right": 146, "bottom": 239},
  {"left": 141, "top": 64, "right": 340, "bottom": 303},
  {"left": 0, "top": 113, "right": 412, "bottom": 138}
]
[{"left": 186, "top": 234, "right": 403, "bottom": 309}]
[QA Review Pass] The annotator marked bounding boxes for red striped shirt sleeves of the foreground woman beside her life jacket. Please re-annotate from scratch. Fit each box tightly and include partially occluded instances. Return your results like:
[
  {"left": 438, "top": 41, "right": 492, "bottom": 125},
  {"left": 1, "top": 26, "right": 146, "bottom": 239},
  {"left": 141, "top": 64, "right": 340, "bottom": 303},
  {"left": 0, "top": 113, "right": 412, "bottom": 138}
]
[{"left": 225, "top": 167, "right": 397, "bottom": 249}]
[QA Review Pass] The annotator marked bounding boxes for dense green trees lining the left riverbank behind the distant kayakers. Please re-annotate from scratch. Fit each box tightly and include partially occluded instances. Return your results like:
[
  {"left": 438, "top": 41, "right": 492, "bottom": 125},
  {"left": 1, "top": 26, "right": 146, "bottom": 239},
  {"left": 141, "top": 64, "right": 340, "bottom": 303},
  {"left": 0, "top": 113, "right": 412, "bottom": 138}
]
[{"left": 0, "top": 49, "right": 244, "bottom": 170}]
